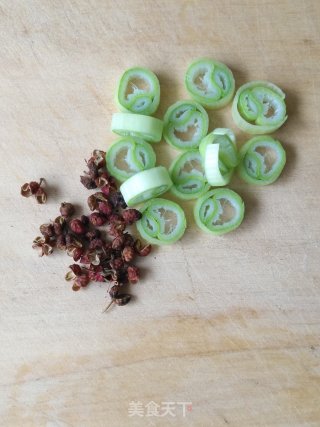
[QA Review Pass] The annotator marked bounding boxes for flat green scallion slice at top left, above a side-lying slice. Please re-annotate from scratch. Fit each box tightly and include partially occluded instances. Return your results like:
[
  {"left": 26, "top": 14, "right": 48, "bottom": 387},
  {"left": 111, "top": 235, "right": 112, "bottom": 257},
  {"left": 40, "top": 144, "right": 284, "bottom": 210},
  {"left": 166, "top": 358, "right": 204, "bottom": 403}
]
[{"left": 117, "top": 67, "right": 160, "bottom": 116}]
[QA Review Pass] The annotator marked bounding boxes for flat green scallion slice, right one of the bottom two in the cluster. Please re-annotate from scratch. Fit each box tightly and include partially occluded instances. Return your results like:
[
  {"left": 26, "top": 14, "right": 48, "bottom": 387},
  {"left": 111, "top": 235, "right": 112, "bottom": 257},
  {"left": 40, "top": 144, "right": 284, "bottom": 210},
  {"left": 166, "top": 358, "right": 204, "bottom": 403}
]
[{"left": 194, "top": 188, "right": 244, "bottom": 236}]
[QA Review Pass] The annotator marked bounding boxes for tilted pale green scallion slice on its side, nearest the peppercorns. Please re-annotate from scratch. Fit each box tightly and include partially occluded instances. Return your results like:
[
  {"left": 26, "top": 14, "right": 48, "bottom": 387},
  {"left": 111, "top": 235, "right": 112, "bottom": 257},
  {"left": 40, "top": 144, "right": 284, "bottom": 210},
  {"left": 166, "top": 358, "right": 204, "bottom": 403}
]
[{"left": 120, "top": 166, "right": 172, "bottom": 206}]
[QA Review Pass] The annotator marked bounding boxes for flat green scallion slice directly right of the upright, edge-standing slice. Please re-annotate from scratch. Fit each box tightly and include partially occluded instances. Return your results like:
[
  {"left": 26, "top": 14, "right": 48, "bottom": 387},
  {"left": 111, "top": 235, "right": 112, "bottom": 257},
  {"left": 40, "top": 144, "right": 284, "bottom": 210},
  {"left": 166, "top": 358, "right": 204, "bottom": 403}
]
[{"left": 238, "top": 135, "right": 286, "bottom": 185}]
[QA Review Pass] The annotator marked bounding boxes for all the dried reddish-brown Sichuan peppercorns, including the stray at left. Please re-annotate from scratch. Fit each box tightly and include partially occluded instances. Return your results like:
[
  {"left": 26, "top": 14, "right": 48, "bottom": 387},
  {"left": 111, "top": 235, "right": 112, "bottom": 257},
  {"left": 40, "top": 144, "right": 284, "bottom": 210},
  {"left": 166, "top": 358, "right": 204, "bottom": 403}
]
[{"left": 21, "top": 150, "right": 151, "bottom": 308}]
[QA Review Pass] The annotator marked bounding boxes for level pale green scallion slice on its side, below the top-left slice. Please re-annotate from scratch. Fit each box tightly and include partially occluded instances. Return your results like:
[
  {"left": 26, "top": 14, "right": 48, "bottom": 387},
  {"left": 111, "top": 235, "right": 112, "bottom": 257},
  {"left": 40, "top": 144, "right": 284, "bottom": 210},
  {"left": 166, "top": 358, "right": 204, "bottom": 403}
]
[{"left": 111, "top": 113, "right": 163, "bottom": 142}]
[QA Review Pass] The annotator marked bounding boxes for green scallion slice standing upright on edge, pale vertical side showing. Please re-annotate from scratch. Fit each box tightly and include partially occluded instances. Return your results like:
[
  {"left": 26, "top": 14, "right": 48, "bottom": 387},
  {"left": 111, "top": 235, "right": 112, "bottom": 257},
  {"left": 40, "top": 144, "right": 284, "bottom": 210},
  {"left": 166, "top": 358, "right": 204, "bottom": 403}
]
[{"left": 199, "top": 128, "right": 239, "bottom": 187}]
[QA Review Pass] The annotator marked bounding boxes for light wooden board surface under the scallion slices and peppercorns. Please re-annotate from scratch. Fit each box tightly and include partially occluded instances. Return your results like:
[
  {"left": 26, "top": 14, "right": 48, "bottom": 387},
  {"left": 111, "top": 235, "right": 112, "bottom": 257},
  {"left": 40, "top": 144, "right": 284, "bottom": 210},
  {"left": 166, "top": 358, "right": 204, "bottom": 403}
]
[{"left": 0, "top": 0, "right": 320, "bottom": 427}]
